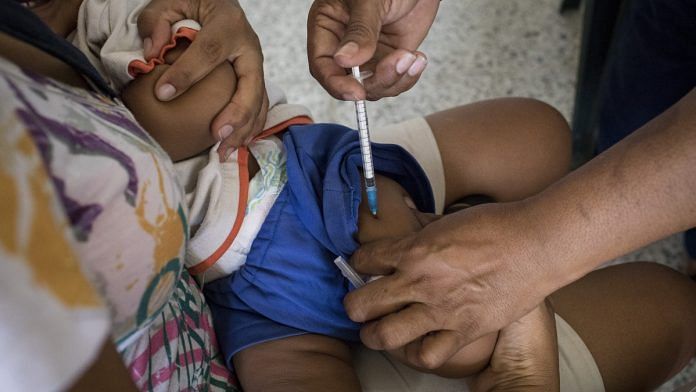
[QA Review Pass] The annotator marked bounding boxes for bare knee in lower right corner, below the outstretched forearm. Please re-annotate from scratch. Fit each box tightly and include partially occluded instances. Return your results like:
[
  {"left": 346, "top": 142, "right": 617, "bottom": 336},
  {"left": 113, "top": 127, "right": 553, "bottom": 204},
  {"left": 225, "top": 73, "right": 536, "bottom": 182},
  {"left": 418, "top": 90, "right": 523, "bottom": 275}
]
[{"left": 551, "top": 263, "right": 696, "bottom": 391}]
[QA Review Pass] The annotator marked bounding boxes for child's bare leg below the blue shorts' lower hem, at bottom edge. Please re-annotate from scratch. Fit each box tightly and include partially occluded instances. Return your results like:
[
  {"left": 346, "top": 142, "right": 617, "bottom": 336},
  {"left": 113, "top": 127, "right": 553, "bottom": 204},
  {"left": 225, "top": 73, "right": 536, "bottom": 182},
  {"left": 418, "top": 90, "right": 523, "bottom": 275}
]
[{"left": 233, "top": 334, "right": 360, "bottom": 392}]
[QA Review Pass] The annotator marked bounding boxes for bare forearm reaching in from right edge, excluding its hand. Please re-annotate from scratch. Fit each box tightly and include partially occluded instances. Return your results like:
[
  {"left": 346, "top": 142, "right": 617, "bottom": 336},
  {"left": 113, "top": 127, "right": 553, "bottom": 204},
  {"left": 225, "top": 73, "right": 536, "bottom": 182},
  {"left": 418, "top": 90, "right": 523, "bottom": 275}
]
[{"left": 528, "top": 89, "right": 696, "bottom": 287}]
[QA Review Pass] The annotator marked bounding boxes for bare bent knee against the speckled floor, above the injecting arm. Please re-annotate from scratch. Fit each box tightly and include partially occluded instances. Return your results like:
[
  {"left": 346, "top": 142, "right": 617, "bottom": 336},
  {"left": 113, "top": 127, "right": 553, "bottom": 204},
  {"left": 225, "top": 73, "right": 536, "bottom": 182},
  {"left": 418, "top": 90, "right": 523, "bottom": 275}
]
[{"left": 426, "top": 98, "right": 571, "bottom": 206}]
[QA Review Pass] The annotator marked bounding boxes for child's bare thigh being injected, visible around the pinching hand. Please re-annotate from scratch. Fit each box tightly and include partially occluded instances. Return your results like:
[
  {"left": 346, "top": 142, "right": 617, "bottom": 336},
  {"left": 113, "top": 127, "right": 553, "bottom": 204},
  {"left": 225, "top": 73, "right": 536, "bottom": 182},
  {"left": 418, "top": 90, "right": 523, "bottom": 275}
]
[{"left": 358, "top": 175, "right": 498, "bottom": 378}]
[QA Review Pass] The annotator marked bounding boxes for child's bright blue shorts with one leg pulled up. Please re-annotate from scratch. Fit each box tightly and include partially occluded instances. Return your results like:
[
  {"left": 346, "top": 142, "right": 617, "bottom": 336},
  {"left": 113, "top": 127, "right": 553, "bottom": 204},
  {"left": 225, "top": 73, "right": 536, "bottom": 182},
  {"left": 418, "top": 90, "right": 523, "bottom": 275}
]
[{"left": 204, "top": 124, "right": 434, "bottom": 367}]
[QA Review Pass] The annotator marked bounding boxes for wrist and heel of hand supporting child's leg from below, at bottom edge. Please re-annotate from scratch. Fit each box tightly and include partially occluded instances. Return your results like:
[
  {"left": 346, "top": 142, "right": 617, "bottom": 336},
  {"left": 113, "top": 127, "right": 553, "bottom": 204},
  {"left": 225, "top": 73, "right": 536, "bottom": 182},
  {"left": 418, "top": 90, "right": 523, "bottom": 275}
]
[{"left": 470, "top": 301, "right": 560, "bottom": 392}]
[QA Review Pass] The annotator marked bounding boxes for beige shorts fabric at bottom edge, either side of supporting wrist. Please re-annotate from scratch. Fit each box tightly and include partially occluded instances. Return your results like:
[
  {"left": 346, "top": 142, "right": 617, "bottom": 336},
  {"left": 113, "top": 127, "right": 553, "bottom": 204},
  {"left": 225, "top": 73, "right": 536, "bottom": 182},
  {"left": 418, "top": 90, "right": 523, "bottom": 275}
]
[{"left": 353, "top": 315, "right": 604, "bottom": 392}]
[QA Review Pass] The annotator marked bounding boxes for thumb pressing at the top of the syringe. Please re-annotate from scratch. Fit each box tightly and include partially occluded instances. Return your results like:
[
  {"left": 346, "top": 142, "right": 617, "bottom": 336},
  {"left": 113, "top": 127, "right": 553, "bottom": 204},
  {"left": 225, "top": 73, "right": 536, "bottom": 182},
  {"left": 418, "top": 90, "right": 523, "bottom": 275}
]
[{"left": 334, "top": 0, "right": 382, "bottom": 68}]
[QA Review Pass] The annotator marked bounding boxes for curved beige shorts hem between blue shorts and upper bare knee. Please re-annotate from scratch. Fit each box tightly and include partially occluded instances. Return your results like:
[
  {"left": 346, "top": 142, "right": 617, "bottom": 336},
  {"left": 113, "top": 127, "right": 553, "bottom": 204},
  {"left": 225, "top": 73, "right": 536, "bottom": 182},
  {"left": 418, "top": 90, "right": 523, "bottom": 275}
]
[{"left": 370, "top": 117, "right": 445, "bottom": 214}]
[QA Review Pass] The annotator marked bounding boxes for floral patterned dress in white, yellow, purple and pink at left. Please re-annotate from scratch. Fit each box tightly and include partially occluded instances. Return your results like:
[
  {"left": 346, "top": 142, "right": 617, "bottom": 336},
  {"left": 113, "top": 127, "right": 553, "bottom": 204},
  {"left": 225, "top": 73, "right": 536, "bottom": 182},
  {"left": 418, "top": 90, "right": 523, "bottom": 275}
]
[{"left": 0, "top": 57, "right": 236, "bottom": 391}]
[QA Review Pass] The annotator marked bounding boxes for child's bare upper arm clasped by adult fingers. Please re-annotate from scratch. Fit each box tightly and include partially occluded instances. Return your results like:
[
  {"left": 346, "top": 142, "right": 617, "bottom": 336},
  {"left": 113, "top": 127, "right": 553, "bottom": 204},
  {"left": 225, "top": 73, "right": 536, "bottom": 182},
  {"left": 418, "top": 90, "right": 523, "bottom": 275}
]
[{"left": 122, "top": 40, "right": 237, "bottom": 161}]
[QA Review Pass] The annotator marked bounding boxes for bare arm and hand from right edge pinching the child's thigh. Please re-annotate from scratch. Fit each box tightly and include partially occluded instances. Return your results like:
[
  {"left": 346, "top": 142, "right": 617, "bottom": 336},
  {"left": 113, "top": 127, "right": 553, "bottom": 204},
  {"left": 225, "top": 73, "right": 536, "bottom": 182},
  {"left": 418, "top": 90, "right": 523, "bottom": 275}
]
[{"left": 346, "top": 90, "right": 696, "bottom": 365}]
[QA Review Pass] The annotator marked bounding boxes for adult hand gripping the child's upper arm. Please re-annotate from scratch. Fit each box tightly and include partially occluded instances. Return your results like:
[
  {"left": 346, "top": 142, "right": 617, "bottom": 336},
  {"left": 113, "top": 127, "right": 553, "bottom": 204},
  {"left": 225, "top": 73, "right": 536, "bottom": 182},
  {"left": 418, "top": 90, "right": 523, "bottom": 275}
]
[{"left": 138, "top": 0, "right": 268, "bottom": 156}]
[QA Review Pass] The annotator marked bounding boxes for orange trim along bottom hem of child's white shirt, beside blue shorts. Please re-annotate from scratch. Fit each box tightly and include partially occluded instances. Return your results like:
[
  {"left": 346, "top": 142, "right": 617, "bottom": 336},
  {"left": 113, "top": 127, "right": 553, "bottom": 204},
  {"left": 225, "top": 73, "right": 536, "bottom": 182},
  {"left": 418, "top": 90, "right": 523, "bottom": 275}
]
[{"left": 188, "top": 116, "right": 313, "bottom": 275}]
